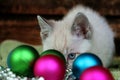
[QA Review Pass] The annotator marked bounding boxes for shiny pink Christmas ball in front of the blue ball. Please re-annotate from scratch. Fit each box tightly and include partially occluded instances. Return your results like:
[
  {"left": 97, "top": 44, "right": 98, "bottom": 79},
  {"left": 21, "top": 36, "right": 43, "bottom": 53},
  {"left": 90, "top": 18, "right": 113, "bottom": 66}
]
[{"left": 79, "top": 66, "right": 114, "bottom": 80}]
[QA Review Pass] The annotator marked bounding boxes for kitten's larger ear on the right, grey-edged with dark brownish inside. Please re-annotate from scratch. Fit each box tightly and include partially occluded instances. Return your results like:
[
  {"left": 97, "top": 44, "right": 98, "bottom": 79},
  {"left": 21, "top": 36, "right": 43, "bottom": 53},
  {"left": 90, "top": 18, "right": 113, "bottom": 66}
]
[{"left": 71, "top": 12, "right": 92, "bottom": 39}]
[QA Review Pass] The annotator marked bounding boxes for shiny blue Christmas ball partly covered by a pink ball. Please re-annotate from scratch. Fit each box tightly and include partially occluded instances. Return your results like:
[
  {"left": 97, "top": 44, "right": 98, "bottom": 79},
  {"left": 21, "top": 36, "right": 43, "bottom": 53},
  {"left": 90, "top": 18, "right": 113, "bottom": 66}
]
[{"left": 72, "top": 53, "right": 103, "bottom": 78}]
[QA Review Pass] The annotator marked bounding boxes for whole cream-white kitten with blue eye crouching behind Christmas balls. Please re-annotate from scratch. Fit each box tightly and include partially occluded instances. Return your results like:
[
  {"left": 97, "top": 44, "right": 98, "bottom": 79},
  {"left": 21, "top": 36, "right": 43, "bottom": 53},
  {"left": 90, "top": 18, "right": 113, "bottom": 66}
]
[{"left": 37, "top": 5, "right": 114, "bottom": 67}]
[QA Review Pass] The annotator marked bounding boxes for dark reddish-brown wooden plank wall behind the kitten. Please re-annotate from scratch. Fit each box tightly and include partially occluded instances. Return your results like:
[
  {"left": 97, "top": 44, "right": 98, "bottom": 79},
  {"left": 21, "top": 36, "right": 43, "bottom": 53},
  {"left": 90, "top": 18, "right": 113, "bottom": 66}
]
[{"left": 0, "top": 0, "right": 120, "bottom": 55}]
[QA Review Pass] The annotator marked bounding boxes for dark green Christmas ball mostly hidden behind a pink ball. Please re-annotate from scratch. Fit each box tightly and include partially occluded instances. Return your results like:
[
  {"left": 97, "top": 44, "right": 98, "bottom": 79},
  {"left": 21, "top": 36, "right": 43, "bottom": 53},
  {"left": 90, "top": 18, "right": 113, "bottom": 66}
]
[{"left": 41, "top": 49, "right": 66, "bottom": 64}]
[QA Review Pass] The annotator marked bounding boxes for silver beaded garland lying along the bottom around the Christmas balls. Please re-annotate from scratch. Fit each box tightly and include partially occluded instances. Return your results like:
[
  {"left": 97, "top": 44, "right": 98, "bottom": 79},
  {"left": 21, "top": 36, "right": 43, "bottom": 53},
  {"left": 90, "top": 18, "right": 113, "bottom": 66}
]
[{"left": 0, "top": 66, "right": 76, "bottom": 80}]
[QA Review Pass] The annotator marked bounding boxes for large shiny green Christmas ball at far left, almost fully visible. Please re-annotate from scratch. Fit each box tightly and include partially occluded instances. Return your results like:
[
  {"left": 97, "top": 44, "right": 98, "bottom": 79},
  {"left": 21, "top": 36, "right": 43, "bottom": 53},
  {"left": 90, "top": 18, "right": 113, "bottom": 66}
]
[{"left": 7, "top": 45, "right": 39, "bottom": 77}]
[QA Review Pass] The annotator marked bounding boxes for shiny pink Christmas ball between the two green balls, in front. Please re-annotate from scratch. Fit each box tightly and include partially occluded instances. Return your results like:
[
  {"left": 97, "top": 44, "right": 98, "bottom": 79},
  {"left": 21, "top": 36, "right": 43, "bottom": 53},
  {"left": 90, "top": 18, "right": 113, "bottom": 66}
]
[{"left": 34, "top": 54, "right": 66, "bottom": 80}]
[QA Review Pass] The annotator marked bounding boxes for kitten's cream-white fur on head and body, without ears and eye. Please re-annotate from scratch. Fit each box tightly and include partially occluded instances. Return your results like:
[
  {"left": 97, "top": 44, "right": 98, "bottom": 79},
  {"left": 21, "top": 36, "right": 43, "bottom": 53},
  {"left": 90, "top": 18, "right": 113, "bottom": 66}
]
[{"left": 37, "top": 6, "right": 114, "bottom": 67}]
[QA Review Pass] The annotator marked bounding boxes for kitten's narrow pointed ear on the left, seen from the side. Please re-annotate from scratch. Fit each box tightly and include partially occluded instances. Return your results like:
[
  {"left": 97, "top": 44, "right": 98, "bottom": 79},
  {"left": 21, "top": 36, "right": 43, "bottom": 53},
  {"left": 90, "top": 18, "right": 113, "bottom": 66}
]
[{"left": 37, "top": 15, "right": 53, "bottom": 40}]
